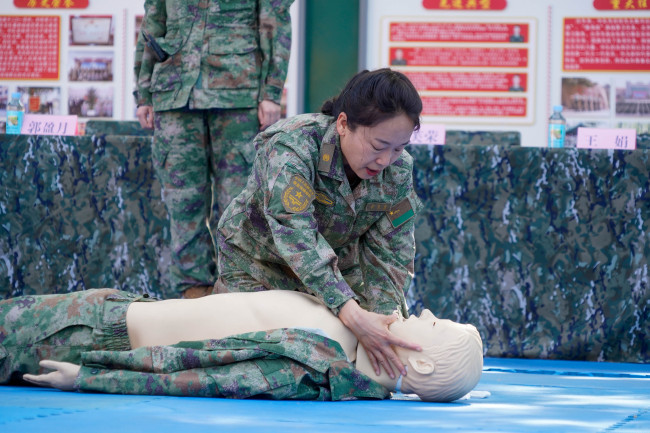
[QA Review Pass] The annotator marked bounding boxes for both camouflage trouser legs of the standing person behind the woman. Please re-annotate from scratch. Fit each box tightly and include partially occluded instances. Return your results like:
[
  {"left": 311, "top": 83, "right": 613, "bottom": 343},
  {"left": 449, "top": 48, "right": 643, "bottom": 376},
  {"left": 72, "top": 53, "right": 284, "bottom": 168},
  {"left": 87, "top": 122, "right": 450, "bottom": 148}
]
[{"left": 152, "top": 108, "right": 259, "bottom": 295}]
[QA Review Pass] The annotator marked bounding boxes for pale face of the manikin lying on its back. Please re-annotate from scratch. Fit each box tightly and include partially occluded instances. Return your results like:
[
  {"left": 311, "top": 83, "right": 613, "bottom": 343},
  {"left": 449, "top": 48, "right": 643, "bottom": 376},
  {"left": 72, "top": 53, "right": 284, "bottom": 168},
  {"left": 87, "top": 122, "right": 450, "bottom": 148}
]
[{"left": 390, "top": 310, "right": 469, "bottom": 351}]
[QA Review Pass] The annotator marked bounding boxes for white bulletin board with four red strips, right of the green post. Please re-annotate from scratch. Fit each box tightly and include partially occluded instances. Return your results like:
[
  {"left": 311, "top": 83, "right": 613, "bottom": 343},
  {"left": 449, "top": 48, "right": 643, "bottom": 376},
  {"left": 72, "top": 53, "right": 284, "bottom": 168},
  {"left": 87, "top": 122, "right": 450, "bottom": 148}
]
[{"left": 365, "top": 0, "right": 650, "bottom": 145}]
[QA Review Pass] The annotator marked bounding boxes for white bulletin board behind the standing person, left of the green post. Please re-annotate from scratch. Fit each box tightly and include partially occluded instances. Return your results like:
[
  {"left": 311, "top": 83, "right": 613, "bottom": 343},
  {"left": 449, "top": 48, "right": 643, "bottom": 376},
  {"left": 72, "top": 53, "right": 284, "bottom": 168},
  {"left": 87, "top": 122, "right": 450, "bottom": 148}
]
[{"left": 0, "top": 0, "right": 299, "bottom": 132}]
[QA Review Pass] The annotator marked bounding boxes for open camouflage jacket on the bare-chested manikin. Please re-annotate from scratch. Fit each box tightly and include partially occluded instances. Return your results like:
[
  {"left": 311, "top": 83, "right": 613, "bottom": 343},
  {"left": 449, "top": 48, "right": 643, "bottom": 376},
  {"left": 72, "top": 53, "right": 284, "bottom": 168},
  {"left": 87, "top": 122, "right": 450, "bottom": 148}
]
[{"left": 75, "top": 329, "right": 390, "bottom": 400}]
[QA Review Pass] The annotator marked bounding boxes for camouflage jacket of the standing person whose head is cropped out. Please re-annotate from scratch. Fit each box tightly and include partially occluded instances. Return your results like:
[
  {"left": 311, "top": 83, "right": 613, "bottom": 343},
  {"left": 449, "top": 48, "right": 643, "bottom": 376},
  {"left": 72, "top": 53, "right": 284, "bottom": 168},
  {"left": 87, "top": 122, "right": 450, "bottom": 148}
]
[{"left": 134, "top": 0, "right": 293, "bottom": 111}]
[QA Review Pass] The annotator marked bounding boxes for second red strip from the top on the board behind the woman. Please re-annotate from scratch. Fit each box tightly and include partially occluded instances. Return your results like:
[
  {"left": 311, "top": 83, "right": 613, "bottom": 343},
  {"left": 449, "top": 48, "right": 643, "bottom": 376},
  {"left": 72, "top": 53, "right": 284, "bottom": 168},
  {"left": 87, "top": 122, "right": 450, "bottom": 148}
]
[{"left": 390, "top": 47, "right": 528, "bottom": 68}]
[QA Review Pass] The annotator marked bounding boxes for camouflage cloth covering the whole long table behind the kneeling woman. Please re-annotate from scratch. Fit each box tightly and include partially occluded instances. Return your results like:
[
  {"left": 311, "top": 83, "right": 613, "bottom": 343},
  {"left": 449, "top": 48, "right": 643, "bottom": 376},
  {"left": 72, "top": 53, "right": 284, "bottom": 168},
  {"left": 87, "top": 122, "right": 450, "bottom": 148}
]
[{"left": 0, "top": 135, "right": 650, "bottom": 362}]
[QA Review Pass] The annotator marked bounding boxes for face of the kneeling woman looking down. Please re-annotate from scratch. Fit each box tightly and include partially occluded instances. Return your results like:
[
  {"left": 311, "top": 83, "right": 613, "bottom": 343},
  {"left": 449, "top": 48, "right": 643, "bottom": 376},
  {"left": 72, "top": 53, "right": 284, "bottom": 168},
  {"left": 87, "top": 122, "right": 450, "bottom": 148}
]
[{"left": 336, "top": 113, "right": 415, "bottom": 179}]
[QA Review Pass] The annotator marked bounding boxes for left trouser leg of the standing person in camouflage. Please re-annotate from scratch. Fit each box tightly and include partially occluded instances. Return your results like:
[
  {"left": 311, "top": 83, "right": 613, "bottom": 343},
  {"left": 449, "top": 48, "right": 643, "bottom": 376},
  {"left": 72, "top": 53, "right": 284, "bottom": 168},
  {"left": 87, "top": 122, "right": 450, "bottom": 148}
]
[{"left": 152, "top": 110, "right": 216, "bottom": 296}]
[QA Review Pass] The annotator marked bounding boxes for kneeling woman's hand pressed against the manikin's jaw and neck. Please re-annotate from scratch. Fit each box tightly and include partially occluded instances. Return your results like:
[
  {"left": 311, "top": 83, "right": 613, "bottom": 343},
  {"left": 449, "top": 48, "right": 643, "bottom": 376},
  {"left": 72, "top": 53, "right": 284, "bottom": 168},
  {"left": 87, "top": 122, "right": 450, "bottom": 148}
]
[{"left": 339, "top": 299, "right": 422, "bottom": 379}]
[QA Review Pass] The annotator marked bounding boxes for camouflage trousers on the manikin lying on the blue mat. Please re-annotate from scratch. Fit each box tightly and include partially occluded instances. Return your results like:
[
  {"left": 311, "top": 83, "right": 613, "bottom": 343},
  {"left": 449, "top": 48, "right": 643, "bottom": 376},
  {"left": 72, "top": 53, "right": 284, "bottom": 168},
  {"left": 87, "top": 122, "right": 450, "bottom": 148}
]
[{"left": 0, "top": 289, "right": 153, "bottom": 384}]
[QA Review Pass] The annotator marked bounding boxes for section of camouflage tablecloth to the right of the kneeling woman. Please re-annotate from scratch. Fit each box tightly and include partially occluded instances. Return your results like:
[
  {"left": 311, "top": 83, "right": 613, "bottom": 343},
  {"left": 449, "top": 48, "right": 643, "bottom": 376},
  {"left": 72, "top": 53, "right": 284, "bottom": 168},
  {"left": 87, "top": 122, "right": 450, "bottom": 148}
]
[{"left": 407, "top": 145, "right": 650, "bottom": 362}]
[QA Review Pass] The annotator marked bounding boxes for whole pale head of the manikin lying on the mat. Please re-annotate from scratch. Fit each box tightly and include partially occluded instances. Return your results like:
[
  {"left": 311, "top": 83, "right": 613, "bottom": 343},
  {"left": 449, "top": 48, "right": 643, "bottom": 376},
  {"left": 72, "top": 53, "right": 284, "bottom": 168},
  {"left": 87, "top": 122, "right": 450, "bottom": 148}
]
[{"left": 390, "top": 310, "right": 483, "bottom": 402}]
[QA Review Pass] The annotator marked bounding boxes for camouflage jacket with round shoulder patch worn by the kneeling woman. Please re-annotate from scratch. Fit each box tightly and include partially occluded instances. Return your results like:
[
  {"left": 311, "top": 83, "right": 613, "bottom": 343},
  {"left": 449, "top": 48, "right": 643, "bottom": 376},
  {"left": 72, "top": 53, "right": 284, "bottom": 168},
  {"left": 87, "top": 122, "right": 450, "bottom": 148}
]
[{"left": 218, "top": 114, "right": 422, "bottom": 317}]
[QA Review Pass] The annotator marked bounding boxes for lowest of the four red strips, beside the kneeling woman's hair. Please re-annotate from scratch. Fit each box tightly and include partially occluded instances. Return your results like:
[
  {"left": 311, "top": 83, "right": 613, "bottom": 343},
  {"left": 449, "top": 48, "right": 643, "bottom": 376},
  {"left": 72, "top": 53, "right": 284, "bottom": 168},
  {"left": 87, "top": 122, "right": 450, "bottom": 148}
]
[{"left": 422, "top": 96, "right": 526, "bottom": 117}]
